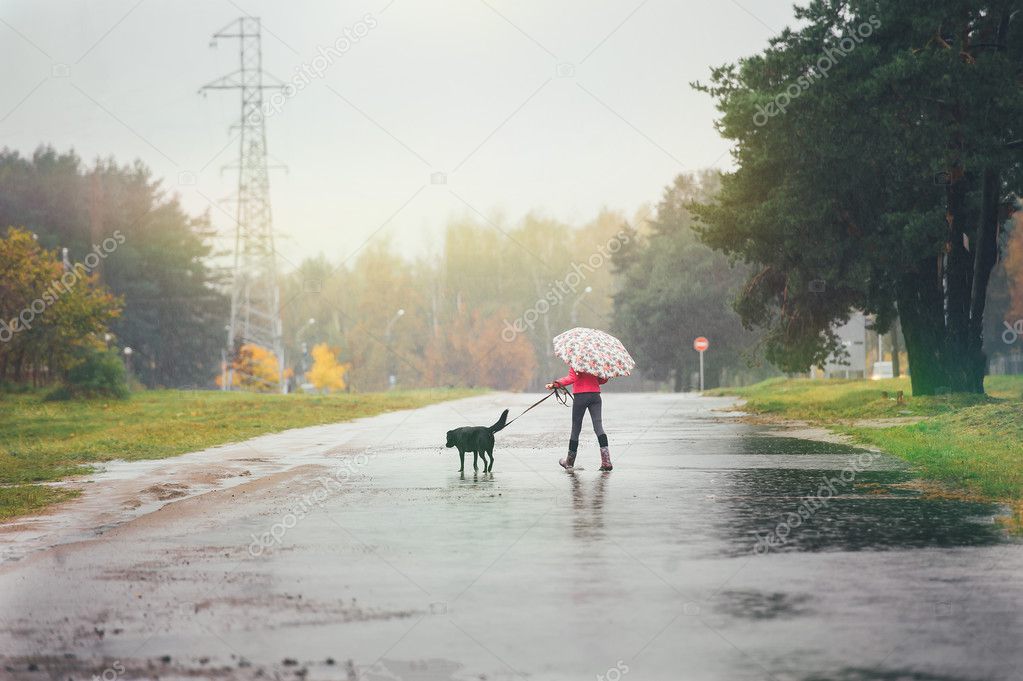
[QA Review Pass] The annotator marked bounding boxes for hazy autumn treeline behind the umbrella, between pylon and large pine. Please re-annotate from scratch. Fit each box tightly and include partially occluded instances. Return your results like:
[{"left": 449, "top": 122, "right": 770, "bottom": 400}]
[{"left": 282, "top": 167, "right": 770, "bottom": 390}]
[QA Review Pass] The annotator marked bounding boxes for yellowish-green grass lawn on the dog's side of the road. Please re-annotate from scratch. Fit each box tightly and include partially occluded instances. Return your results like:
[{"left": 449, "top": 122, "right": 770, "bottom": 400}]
[{"left": 0, "top": 390, "right": 480, "bottom": 519}]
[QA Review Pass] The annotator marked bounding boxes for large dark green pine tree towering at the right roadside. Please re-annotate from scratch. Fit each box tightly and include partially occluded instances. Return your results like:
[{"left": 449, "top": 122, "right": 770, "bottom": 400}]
[{"left": 696, "top": 0, "right": 1023, "bottom": 395}]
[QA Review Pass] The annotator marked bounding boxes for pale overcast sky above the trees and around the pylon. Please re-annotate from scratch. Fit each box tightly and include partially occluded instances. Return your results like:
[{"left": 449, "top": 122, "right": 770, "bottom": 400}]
[{"left": 0, "top": 0, "right": 792, "bottom": 269}]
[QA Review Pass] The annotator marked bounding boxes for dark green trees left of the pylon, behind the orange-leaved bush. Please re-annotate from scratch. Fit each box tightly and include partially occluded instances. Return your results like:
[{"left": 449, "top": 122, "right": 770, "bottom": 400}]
[{"left": 0, "top": 147, "right": 228, "bottom": 387}]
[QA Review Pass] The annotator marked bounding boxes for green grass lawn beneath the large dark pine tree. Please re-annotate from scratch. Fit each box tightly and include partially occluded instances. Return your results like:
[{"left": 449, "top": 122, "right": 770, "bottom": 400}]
[{"left": 708, "top": 376, "right": 1023, "bottom": 507}]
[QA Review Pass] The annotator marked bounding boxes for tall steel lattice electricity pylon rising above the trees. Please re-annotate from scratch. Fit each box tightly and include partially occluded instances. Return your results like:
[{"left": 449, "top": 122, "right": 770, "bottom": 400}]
[{"left": 201, "top": 16, "right": 287, "bottom": 393}]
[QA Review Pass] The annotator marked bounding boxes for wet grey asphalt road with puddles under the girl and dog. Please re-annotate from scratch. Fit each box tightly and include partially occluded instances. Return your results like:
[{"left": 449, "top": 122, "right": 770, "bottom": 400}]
[{"left": 0, "top": 394, "right": 1023, "bottom": 681}]
